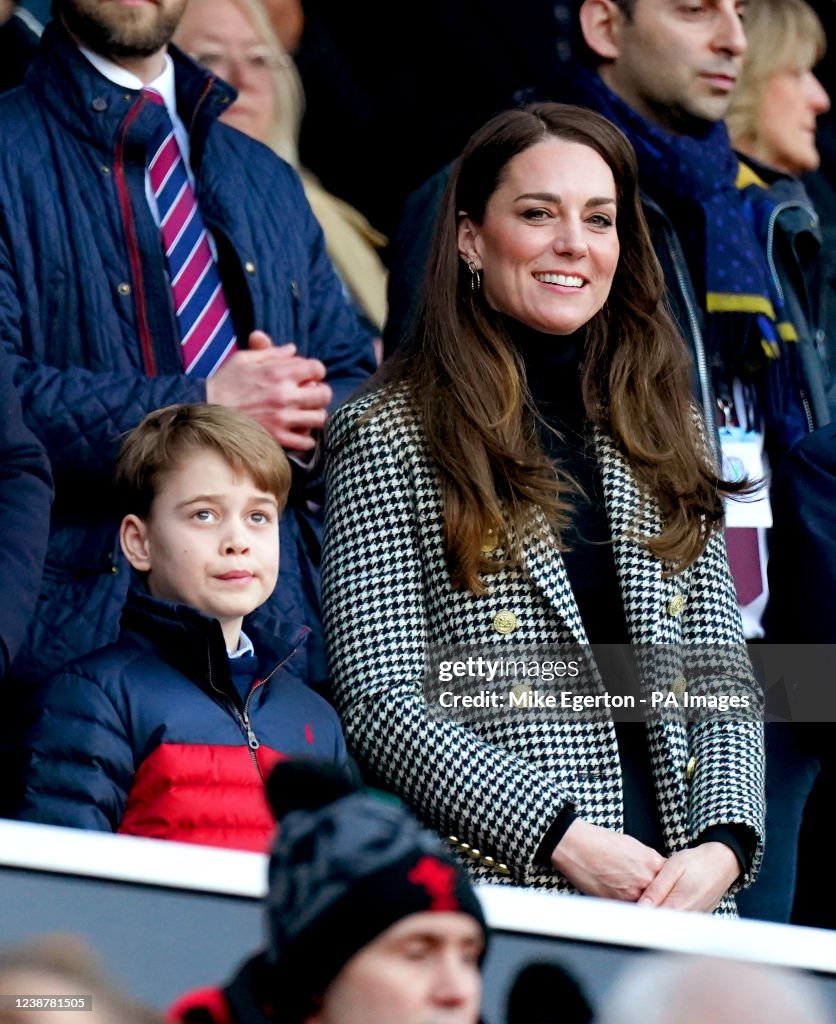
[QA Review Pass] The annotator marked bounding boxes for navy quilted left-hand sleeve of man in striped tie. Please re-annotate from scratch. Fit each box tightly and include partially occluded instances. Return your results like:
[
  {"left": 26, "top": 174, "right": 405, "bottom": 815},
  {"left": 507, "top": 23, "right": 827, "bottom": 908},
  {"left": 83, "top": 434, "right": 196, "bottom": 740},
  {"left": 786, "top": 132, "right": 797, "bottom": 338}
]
[{"left": 0, "top": 240, "right": 206, "bottom": 479}]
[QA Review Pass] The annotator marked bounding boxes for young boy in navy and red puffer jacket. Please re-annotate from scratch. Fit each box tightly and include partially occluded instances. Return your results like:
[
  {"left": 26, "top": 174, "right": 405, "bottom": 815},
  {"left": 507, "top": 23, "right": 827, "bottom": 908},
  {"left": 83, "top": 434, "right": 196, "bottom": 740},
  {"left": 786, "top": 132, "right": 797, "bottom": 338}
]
[{"left": 20, "top": 404, "right": 349, "bottom": 852}]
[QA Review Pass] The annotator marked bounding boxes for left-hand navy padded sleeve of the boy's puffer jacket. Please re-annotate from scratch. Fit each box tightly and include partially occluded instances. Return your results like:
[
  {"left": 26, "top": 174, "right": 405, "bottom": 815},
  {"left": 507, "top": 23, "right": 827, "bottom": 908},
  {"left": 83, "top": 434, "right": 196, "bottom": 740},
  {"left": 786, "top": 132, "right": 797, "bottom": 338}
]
[{"left": 20, "top": 669, "right": 134, "bottom": 831}]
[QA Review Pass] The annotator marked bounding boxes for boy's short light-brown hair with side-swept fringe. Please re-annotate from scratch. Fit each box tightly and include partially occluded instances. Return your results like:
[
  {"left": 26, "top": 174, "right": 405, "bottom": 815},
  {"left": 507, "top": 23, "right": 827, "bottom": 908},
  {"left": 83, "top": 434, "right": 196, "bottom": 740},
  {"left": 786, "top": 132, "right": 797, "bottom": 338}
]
[{"left": 114, "top": 402, "right": 291, "bottom": 519}]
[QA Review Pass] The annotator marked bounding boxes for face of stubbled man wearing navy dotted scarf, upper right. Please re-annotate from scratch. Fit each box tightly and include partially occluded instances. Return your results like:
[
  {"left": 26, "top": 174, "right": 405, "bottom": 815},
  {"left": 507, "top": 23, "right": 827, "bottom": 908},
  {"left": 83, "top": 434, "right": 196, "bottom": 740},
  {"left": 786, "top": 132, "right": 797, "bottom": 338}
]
[{"left": 600, "top": 0, "right": 746, "bottom": 134}]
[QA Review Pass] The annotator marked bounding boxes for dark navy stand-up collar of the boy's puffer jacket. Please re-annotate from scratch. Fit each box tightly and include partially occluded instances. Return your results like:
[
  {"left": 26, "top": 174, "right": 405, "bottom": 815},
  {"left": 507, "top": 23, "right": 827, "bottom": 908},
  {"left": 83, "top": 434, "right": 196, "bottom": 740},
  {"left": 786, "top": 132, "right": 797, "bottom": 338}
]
[{"left": 120, "top": 584, "right": 309, "bottom": 699}]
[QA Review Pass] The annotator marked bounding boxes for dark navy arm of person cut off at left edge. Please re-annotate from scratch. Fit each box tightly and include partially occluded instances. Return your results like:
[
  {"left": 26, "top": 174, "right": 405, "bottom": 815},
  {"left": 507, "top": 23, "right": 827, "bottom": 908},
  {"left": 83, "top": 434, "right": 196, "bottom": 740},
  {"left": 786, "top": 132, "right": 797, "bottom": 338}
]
[{"left": 0, "top": 353, "right": 52, "bottom": 680}]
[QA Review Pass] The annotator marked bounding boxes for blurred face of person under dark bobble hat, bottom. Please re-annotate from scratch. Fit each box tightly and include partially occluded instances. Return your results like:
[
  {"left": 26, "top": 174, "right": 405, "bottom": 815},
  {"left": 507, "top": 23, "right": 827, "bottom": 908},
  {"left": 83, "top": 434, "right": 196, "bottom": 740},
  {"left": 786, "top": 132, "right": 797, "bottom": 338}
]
[{"left": 305, "top": 911, "right": 484, "bottom": 1024}]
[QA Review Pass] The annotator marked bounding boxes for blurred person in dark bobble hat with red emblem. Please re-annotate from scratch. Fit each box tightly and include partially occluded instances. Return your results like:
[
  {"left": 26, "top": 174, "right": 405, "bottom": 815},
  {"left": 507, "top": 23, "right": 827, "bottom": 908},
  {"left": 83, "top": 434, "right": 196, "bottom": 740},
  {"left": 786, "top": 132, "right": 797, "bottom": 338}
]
[{"left": 168, "top": 761, "right": 488, "bottom": 1024}]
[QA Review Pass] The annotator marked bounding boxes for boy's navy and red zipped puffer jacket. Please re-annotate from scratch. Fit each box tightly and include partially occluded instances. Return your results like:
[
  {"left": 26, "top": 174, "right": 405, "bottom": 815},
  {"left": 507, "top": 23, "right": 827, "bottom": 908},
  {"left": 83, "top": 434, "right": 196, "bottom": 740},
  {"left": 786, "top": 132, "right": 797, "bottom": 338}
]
[{"left": 20, "top": 590, "right": 350, "bottom": 852}]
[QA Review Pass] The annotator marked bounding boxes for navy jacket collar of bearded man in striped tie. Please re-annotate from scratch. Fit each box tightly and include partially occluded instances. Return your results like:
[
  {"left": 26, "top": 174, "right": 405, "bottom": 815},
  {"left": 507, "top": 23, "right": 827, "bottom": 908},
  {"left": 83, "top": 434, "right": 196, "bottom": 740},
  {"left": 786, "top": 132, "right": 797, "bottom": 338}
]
[{"left": 26, "top": 20, "right": 238, "bottom": 157}]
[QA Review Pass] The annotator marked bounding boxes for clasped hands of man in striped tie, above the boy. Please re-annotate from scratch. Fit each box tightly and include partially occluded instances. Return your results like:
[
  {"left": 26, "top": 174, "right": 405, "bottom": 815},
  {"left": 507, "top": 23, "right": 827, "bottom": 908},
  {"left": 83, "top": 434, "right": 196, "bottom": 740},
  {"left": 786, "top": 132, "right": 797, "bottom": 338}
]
[{"left": 206, "top": 331, "right": 333, "bottom": 452}]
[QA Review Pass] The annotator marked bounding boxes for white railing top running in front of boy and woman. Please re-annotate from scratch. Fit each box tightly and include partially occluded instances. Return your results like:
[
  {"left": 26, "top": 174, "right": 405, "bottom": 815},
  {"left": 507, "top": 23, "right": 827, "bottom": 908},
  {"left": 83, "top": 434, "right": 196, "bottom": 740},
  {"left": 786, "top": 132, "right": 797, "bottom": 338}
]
[{"left": 0, "top": 821, "right": 836, "bottom": 974}]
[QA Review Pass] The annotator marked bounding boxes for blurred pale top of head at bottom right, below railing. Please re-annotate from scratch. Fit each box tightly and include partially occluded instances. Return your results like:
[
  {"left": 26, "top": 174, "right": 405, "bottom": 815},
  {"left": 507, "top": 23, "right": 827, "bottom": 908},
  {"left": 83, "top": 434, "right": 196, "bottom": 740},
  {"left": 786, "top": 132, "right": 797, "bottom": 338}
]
[{"left": 594, "top": 953, "right": 831, "bottom": 1024}]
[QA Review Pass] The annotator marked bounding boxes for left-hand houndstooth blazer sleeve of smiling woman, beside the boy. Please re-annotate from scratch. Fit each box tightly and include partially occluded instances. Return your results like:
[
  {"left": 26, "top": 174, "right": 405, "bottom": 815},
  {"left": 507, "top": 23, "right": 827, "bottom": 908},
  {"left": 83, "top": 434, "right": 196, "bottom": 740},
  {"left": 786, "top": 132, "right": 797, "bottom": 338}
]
[{"left": 322, "top": 406, "right": 569, "bottom": 879}]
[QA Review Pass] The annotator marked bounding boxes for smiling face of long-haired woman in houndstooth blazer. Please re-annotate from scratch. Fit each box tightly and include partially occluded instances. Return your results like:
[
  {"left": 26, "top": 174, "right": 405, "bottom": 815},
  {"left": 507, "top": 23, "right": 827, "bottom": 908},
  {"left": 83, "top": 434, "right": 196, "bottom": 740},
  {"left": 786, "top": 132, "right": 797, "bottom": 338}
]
[{"left": 459, "top": 138, "right": 619, "bottom": 335}]
